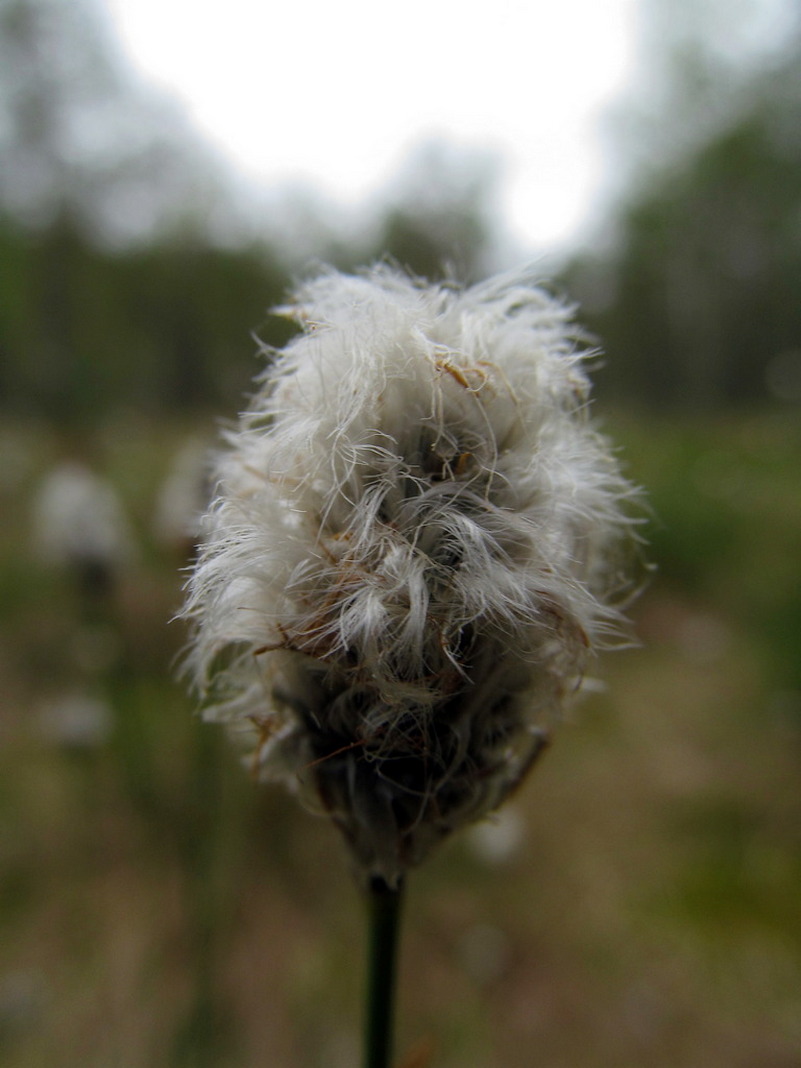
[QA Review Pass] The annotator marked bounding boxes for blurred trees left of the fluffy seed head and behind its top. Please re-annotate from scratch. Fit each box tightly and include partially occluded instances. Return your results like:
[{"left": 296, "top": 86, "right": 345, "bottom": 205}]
[{"left": 0, "top": 0, "right": 499, "bottom": 425}]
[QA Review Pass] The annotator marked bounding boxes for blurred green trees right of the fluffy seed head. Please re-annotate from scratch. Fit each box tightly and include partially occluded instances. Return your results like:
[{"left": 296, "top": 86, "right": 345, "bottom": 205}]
[{"left": 565, "top": 0, "right": 801, "bottom": 409}]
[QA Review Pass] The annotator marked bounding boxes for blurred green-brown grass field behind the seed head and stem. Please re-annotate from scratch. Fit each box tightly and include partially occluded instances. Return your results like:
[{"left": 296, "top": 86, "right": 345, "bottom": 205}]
[{"left": 0, "top": 408, "right": 801, "bottom": 1068}]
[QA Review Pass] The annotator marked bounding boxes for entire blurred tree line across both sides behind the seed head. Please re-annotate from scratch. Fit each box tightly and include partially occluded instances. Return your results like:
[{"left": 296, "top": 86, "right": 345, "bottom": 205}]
[{"left": 0, "top": 0, "right": 801, "bottom": 423}]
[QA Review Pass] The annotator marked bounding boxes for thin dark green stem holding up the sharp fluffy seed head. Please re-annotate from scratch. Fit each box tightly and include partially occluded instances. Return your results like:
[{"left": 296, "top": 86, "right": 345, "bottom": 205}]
[{"left": 364, "top": 878, "right": 403, "bottom": 1068}]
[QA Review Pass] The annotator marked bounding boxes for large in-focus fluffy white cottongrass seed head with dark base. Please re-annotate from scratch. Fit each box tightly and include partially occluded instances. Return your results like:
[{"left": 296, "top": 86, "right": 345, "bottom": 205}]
[{"left": 184, "top": 266, "right": 634, "bottom": 885}]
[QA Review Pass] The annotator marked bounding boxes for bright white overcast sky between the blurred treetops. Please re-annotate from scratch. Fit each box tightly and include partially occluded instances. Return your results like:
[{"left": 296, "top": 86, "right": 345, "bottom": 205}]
[{"left": 103, "top": 0, "right": 639, "bottom": 250}]
